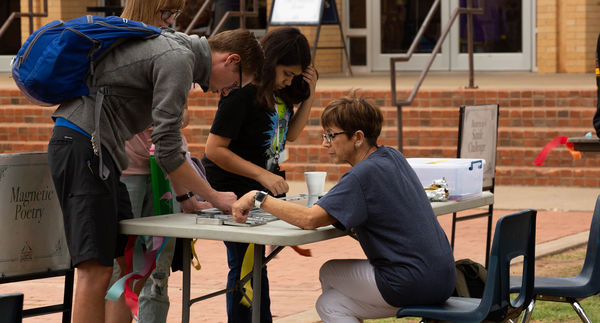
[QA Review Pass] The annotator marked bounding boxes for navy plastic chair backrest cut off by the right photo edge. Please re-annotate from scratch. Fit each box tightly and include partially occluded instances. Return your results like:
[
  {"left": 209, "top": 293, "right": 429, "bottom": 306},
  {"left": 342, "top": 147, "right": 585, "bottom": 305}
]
[{"left": 579, "top": 195, "right": 600, "bottom": 295}]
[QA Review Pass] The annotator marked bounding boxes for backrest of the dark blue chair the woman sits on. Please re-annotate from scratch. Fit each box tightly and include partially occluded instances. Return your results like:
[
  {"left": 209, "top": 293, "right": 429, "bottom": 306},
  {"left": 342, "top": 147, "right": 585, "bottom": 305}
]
[{"left": 479, "top": 210, "right": 537, "bottom": 320}]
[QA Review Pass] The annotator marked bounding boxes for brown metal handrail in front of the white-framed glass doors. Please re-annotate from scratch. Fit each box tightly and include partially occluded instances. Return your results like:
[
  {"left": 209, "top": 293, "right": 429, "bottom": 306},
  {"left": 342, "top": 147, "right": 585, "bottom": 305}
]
[{"left": 390, "top": 0, "right": 485, "bottom": 151}]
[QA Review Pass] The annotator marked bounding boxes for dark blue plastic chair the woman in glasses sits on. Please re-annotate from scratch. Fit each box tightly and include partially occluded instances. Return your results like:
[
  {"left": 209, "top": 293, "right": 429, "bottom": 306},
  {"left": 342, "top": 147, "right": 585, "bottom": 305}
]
[{"left": 396, "top": 210, "right": 537, "bottom": 322}]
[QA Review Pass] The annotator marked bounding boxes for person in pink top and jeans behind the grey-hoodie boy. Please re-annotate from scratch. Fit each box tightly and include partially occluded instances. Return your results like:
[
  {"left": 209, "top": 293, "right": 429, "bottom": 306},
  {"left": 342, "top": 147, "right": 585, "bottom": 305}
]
[{"left": 107, "top": 0, "right": 227, "bottom": 323}]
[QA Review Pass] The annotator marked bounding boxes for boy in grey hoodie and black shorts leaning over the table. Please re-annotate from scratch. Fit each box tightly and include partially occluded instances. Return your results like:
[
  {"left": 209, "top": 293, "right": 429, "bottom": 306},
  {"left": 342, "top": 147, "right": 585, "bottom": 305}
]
[{"left": 48, "top": 29, "right": 264, "bottom": 323}]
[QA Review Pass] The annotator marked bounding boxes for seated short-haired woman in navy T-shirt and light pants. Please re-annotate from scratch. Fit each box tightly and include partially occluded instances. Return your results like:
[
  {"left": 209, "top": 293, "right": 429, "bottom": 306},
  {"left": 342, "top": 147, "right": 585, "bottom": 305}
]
[{"left": 232, "top": 97, "right": 456, "bottom": 322}]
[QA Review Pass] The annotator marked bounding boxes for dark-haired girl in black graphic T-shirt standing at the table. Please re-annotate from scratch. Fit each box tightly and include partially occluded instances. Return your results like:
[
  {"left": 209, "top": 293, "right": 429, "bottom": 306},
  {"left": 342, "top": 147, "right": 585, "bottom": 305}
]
[{"left": 202, "top": 27, "right": 317, "bottom": 322}]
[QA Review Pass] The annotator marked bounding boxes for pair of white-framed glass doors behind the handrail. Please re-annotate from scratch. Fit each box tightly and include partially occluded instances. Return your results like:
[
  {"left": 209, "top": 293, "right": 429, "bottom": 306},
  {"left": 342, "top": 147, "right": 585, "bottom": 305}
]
[{"left": 366, "top": 0, "right": 536, "bottom": 71}]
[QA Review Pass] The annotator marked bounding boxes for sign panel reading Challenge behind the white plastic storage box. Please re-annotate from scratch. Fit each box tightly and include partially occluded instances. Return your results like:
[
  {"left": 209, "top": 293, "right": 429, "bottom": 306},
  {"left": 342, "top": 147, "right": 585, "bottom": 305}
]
[{"left": 456, "top": 104, "right": 500, "bottom": 191}]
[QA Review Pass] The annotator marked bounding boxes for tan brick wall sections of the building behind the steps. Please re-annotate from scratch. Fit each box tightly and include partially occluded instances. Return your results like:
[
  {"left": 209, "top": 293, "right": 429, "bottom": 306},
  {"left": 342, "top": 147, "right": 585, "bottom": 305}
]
[{"left": 11, "top": 0, "right": 600, "bottom": 73}]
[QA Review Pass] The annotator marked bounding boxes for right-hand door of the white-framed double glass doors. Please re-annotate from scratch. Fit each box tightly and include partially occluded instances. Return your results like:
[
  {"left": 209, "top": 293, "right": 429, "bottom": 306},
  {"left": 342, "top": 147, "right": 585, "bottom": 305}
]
[{"left": 450, "top": 0, "right": 535, "bottom": 71}]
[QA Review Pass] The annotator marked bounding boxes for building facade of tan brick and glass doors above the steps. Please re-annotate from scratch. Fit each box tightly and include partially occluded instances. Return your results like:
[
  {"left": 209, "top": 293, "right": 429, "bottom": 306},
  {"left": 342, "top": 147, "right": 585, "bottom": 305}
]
[{"left": 0, "top": 0, "right": 600, "bottom": 73}]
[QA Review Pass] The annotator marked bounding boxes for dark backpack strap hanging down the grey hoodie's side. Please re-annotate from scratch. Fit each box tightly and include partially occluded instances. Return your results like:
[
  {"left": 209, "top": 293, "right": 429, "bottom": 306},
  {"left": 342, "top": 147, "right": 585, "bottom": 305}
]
[{"left": 90, "top": 86, "right": 152, "bottom": 181}]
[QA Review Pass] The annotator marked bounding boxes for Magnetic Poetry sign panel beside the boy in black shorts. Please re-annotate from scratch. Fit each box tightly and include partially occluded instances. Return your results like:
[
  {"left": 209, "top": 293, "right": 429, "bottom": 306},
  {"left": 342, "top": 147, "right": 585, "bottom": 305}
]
[{"left": 0, "top": 153, "right": 71, "bottom": 277}]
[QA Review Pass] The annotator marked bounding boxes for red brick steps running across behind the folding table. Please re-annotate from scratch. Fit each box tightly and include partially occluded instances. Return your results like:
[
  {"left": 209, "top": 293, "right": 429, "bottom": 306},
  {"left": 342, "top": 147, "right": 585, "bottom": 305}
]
[{"left": 0, "top": 89, "right": 600, "bottom": 187}]
